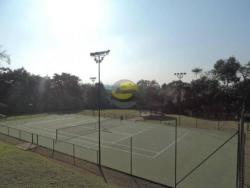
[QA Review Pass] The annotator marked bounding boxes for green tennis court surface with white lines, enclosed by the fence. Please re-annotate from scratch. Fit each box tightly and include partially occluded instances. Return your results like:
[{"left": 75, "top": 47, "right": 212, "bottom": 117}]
[{"left": 0, "top": 114, "right": 237, "bottom": 188}]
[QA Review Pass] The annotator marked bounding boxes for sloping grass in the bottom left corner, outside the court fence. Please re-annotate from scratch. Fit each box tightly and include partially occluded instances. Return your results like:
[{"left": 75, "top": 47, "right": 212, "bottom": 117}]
[{"left": 0, "top": 141, "right": 113, "bottom": 188}]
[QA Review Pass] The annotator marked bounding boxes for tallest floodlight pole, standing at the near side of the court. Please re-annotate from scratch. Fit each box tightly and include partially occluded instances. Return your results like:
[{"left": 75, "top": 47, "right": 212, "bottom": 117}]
[{"left": 90, "top": 50, "right": 110, "bottom": 168}]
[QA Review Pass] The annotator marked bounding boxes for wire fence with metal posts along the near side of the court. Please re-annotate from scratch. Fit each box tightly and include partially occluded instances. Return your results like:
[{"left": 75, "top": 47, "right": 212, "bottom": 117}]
[{"left": 0, "top": 114, "right": 245, "bottom": 188}]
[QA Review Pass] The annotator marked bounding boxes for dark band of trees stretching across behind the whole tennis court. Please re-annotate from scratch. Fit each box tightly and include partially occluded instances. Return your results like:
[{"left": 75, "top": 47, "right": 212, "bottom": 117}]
[{"left": 0, "top": 48, "right": 250, "bottom": 116}]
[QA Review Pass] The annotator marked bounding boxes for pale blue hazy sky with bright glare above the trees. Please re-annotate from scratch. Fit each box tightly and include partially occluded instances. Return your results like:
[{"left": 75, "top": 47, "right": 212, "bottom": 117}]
[{"left": 0, "top": 0, "right": 250, "bottom": 84}]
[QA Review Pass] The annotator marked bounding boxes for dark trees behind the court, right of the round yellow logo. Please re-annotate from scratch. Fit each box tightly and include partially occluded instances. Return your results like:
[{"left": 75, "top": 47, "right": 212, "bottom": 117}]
[{"left": 137, "top": 57, "right": 250, "bottom": 118}]
